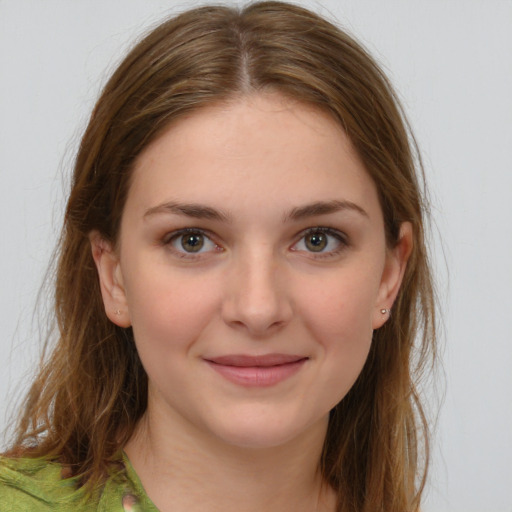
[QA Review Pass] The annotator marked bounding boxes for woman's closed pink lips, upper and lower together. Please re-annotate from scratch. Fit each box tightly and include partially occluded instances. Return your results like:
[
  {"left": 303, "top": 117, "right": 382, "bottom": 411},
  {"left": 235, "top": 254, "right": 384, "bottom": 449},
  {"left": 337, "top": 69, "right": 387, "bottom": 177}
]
[{"left": 204, "top": 354, "right": 308, "bottom": 387}]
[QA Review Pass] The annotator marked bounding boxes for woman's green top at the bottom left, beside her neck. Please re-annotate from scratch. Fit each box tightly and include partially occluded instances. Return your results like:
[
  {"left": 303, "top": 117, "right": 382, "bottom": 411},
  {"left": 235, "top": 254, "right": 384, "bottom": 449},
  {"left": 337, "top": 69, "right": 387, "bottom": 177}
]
[{"left": 0, "top": 454, "right": 158, "bottom": 512}]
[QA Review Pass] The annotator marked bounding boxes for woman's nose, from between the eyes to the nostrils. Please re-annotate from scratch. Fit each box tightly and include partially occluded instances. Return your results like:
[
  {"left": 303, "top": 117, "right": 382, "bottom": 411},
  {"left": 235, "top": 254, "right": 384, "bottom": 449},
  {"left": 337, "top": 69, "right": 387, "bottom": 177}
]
[{"left": 222, "top": 250, "right": 293, "bottom": 337}]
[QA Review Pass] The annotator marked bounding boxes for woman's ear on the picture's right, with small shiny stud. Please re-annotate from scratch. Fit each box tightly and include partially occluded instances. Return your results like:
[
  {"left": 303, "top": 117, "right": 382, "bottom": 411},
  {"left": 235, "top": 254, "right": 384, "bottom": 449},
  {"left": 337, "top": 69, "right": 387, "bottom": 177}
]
[{"left": 373, "top": 222, "right": 413, "bottom": 329}]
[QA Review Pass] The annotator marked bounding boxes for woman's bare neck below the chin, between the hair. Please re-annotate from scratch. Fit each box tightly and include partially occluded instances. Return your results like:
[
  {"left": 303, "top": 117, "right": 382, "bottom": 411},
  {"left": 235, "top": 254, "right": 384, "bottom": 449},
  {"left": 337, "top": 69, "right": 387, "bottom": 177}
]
[{"left": 125, "top": 402, "right": 335, "bottom": 512}]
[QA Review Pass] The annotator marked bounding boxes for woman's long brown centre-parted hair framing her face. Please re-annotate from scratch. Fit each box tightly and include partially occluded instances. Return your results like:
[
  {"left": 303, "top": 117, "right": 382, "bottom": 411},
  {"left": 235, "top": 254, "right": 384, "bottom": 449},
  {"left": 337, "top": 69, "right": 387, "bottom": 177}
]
[{"left": 9, "top": 1, "right": 435, "bottom": 512}]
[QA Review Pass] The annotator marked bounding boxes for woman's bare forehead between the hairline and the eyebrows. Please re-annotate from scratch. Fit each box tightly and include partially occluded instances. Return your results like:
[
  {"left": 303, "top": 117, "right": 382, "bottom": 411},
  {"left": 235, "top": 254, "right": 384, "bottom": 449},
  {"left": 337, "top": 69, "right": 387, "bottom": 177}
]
[{"left": 128, "top": 93, "right": 378, "bottom": 220}]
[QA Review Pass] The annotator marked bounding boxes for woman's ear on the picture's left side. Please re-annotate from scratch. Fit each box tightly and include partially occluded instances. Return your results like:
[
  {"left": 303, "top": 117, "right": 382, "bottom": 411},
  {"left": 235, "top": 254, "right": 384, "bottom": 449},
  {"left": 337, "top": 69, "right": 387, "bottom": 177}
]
[{"left": 89, "top": 231, "right": 131, "bottom": 327}]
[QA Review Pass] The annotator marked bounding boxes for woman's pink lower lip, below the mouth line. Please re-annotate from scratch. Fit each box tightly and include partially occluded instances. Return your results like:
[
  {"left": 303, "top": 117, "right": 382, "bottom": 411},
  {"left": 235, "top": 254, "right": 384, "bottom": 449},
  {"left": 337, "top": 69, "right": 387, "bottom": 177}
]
[{"left": 207, "top": 359, "right": 306, "bottom": 387}]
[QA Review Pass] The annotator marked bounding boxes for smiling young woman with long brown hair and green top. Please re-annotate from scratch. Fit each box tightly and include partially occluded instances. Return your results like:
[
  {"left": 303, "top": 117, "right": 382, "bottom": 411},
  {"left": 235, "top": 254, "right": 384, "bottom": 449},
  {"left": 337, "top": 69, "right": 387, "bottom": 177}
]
[{"left": 0, "top": 2, "right": 435, "bottom": 512}]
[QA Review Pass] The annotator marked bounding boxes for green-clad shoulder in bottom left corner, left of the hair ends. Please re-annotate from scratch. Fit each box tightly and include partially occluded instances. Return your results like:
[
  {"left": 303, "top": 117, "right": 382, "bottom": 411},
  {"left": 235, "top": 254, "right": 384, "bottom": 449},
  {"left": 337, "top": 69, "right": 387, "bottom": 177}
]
[{"left": 0, "top": 457, "right": 96, "bottom": 512}]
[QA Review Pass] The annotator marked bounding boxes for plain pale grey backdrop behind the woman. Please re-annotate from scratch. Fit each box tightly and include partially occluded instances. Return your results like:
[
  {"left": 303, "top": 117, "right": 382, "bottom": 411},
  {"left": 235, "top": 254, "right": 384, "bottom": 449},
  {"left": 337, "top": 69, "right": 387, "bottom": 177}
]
[{"left": 0, "top": 0, "right": 512, "bottom": 512}]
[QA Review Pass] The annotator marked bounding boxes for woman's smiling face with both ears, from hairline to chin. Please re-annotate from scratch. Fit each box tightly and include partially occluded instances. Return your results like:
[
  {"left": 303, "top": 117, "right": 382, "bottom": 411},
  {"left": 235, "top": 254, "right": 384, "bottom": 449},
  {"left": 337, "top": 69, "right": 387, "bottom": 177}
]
[{"left": 91, "top": 94, "right": 410, "bottom": 447}]
